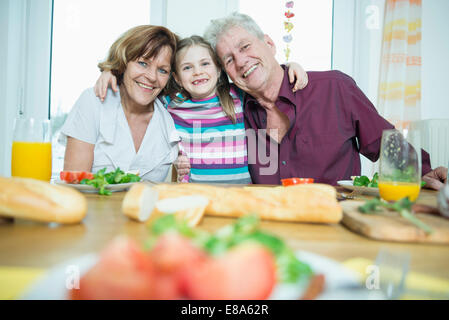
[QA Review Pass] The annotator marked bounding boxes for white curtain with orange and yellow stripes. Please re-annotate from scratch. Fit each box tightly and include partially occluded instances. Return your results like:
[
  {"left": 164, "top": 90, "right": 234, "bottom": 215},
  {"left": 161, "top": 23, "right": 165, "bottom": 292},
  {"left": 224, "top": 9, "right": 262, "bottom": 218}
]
[{"left": 378, "top": 0, "right": 421, "bottom": 129}]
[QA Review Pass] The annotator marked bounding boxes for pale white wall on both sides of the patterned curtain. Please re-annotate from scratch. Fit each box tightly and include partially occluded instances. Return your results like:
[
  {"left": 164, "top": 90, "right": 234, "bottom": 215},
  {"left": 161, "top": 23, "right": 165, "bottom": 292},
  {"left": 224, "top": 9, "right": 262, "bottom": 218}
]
[{"left": 333, "top": 0, "right": 449, "bottom": 119}]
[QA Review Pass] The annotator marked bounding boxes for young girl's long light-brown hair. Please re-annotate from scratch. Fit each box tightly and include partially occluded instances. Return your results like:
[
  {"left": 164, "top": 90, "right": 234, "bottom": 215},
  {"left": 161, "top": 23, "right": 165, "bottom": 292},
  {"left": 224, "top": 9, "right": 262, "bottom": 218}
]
[{"left": 167, "top": 35, "right": 236, "bottom": 124}]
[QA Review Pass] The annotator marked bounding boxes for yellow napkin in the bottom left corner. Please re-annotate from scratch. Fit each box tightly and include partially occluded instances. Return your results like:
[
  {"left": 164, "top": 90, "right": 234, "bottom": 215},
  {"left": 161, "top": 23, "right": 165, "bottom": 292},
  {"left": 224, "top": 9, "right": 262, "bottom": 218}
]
[{"left": 0, "top": 267, "right": 45, "bottom": 300}]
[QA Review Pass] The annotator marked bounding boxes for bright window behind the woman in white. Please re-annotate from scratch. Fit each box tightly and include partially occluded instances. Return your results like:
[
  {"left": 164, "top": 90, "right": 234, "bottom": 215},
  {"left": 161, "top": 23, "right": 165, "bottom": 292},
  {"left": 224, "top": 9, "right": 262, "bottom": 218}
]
[{"left": 50, "top": 0, "right": 150, "bottom": 175}]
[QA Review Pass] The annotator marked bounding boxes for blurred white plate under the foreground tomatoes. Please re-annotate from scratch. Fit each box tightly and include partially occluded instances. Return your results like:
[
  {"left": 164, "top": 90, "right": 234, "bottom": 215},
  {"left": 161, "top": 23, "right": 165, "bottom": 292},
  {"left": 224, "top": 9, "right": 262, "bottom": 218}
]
[{"left": 22, "top": 251, "right": 383, "bottom": 300}]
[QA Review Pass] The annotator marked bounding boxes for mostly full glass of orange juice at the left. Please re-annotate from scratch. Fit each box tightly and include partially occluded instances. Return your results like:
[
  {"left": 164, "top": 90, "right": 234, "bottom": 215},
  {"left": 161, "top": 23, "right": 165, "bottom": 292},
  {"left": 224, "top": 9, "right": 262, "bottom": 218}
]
[{"left": 11, "top": 117, "right": 51, "bottom": 181}]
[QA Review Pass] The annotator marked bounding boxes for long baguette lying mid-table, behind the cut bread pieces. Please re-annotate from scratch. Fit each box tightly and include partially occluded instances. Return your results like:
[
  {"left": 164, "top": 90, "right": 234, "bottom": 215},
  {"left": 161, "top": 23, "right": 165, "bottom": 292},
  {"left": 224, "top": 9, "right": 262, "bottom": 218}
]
[{"left": 147, "top": 183, "right": 343, "bottom": 223}]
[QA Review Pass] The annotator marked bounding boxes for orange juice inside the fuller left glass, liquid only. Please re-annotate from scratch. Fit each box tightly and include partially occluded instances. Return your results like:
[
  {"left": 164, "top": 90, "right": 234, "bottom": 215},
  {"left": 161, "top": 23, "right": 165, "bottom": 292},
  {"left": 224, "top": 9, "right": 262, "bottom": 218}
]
[{"left": 11, "top": 141, "right": 51, "bottom": 181}]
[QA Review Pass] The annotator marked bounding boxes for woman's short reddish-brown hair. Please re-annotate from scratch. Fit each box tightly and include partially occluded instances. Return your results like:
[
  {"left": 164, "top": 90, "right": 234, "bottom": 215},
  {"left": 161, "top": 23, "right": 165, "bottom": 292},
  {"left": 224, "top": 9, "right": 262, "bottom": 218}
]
[{"left": 98, "top": 25, "right": 179, "bottom": 93}]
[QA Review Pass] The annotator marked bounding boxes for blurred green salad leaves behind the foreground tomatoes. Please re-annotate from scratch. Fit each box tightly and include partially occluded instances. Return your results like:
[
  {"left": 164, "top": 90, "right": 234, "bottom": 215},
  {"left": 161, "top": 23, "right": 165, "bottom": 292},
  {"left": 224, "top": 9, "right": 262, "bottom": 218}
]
[{"left": 147, "top": 215, "right": 313, "bottom": 283}]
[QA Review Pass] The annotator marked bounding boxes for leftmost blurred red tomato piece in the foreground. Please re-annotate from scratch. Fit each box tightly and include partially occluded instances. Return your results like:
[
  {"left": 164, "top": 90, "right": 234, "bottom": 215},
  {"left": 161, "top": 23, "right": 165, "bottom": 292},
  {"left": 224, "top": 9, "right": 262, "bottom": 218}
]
[{"left": 70, "top": 238, "right": 155, "bottom": 300}]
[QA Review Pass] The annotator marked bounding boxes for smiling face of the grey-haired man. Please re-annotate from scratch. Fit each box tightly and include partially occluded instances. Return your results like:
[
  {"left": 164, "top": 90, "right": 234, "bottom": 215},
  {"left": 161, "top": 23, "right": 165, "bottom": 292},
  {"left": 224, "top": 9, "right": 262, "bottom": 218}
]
[{"left": 217, "top": 27, "right": 279, "bottom": 94}]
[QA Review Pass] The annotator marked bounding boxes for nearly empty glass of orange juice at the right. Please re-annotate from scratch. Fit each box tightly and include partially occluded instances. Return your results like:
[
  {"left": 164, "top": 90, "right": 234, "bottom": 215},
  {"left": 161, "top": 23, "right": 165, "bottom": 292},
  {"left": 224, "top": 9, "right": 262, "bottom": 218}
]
[{"left": 378, "top": 130, "right": 421, "bottom": 202}]
